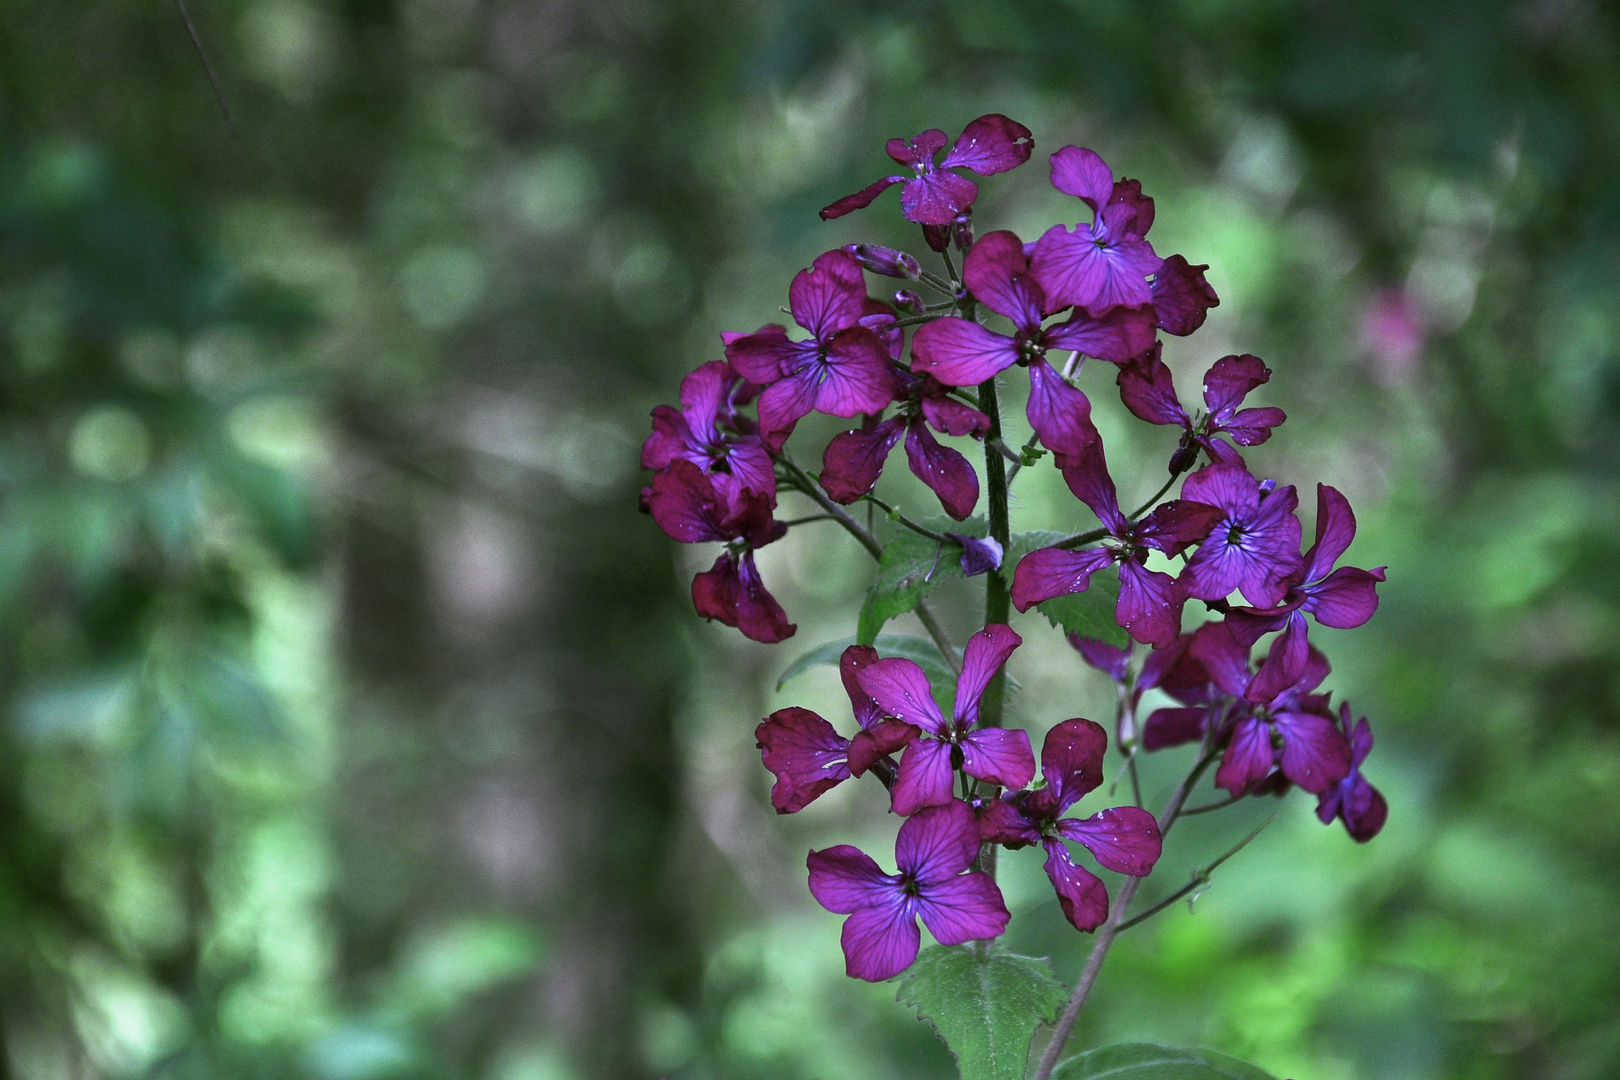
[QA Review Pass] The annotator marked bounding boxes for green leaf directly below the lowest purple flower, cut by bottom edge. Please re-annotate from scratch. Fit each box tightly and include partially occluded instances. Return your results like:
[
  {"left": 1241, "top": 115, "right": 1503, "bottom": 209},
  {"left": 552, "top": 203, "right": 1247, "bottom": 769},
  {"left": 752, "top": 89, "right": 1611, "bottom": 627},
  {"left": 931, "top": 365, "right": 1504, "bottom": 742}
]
[{"left": 896, "top": 946, "right": 1068, "bottom": 1080}]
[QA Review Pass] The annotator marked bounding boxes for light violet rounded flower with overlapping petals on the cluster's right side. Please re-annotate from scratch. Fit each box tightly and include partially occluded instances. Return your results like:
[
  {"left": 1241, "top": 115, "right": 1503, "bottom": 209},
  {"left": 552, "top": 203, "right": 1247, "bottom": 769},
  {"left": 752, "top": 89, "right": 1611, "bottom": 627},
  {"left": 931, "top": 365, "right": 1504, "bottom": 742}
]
[{"left": 1179, "top": 463, "right": 1301, "bottom": 607}]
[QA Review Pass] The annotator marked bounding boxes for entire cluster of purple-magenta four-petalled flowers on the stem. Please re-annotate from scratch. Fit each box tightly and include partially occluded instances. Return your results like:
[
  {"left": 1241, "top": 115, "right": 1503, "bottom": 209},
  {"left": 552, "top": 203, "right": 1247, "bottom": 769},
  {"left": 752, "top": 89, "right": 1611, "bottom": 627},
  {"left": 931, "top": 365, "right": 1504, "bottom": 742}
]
[{"left": 642, "top": 115, "right": 1388, "bottom": 980}]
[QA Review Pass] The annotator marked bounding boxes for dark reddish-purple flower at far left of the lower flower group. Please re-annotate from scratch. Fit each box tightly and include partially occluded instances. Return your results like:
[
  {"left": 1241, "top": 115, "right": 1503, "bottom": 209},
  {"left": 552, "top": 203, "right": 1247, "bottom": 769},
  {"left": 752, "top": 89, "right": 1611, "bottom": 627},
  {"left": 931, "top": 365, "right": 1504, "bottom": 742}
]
[{"left": 753, "top": 644, "right": 919, "bottom": 814}]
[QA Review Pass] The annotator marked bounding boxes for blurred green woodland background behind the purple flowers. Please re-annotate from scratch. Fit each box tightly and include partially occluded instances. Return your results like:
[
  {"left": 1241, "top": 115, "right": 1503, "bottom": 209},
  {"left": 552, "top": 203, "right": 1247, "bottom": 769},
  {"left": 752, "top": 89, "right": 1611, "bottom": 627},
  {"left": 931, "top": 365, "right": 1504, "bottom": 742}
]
[{"left": 0, "top": 0, "right": 1620, "bottom": 1080}]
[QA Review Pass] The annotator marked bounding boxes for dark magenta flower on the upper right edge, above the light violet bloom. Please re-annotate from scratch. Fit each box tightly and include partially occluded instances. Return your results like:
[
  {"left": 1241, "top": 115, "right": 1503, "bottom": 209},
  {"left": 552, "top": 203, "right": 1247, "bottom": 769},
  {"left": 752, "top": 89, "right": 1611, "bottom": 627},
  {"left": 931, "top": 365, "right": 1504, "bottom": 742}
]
[{"left": 1119, "top": 347, "right": 1288, "bottom": 473}]
